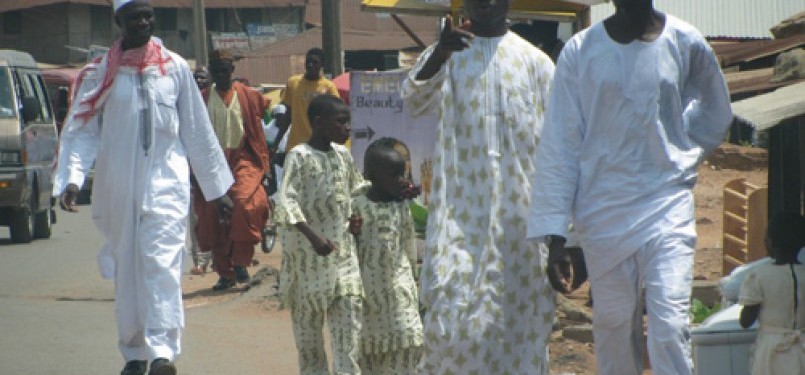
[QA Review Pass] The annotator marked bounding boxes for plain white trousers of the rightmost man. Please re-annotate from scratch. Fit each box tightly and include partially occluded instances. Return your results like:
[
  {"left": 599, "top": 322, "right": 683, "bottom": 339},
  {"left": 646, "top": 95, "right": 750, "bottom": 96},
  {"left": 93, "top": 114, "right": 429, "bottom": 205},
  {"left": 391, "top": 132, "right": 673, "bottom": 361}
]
[{"left": 591, "top": 235, "right": 696, "bottom": 375}]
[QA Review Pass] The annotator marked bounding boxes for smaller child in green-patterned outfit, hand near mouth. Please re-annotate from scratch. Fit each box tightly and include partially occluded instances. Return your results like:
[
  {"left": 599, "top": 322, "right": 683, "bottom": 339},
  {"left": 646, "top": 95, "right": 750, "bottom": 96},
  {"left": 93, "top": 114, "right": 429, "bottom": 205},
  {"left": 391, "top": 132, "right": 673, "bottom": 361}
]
[{"left": 352, "top": 138, "right": 423, "bottom": 375}]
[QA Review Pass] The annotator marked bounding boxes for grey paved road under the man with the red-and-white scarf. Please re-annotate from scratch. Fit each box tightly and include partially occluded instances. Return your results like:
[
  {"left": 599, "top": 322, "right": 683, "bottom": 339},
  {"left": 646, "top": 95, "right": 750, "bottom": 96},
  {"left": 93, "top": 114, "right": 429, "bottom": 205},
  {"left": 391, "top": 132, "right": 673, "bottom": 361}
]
[{"left": 0, "top": 206, "right": 298, "bottom": 375}]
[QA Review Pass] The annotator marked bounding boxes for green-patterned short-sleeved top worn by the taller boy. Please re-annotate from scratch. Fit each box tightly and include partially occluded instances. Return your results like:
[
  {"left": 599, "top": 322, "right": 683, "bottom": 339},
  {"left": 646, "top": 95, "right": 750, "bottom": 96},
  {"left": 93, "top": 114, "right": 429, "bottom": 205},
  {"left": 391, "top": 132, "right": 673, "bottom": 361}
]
[{"left": 276, "top": 144, "right": 363, "bottom": 309}]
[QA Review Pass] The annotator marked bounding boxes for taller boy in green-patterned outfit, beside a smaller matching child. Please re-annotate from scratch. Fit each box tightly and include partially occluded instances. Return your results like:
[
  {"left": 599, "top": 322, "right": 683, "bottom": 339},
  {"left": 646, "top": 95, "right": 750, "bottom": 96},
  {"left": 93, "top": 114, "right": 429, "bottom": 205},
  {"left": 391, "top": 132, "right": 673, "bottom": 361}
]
[{"left": 277, "top": 95, "right": 363, "bottom": 375}]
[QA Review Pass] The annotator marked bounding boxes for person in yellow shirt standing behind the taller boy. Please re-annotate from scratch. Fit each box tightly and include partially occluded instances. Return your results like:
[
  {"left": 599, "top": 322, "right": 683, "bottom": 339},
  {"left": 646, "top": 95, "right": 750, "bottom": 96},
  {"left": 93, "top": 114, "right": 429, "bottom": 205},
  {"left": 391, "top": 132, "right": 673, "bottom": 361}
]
[{"left": 282, "top": 48, "right": 338, "bottom": 151}]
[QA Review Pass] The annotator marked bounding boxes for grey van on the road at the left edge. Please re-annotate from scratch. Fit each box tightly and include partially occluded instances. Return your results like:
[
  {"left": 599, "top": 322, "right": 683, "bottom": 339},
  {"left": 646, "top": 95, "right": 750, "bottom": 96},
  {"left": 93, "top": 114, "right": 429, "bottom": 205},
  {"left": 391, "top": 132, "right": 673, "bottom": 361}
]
[{"left": 0, "top": 50, "right": 58, "bottom": 243}]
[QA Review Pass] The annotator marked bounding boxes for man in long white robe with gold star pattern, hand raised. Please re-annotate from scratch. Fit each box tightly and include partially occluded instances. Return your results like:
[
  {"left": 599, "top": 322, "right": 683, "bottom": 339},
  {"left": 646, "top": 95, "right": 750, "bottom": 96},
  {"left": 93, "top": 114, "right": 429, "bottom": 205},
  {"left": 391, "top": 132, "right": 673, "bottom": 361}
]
[{"left": 403, "top": 0, "right": 555, "bottom": 374}]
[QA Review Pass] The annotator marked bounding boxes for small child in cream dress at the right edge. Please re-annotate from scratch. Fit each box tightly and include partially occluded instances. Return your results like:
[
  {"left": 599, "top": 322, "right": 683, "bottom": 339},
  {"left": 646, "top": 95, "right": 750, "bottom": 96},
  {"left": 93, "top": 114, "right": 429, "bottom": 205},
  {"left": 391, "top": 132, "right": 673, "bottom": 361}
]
[{"left": 738, "top": 213, "right": 805, "bottom": 375}]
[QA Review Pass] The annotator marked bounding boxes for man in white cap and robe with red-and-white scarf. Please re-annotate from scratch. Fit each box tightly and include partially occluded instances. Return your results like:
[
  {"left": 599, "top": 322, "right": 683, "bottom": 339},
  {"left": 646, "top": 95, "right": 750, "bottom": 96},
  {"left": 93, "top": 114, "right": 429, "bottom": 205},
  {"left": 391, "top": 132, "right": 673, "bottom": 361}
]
[{"left": 53, "top": 0, "right": 233, "bottom": 375}]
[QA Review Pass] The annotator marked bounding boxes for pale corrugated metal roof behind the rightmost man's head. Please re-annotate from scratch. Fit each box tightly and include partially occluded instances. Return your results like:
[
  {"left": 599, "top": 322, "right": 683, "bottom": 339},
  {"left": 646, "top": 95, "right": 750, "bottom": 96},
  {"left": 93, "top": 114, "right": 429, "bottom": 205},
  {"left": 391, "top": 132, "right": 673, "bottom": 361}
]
[{"left": 590, "top": 0, "right": 805, "bottom": 38}]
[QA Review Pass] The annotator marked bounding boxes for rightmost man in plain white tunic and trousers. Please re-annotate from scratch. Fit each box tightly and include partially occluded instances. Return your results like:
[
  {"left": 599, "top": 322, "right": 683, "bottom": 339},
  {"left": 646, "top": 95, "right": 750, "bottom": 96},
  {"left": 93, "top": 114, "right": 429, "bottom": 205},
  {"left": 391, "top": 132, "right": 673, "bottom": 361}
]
[{"left": 528, "top": 0, "right": 732, "bottom": 375}]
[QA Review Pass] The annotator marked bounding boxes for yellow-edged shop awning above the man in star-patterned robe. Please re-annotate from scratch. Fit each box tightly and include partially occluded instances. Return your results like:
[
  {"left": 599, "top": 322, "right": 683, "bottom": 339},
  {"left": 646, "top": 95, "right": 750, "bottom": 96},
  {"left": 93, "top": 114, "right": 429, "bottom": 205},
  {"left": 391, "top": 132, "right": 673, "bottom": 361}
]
[{"left": 361, "top": 0, "right": 609, "bottom": 21}]
